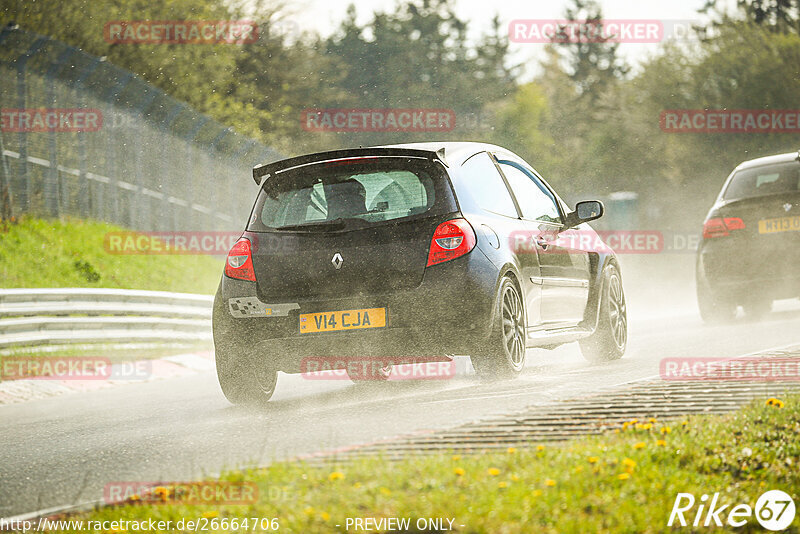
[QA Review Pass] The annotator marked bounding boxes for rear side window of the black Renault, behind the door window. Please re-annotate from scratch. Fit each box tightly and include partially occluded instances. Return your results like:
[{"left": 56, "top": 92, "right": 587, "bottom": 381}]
[{"left": 455, "top": 152, "right": 518, "bottom": 218}]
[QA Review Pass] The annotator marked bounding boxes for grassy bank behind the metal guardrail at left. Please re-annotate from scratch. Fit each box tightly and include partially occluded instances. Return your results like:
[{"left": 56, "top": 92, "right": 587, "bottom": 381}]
[{"left": 0, "top": 218, "right": 223, "bottom": 294}]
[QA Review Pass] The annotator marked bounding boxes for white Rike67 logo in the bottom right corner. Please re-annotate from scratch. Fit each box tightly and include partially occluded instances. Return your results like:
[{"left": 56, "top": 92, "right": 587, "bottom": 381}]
[{"left": 667, "top": 490, "right": 795, "bottom": 531}]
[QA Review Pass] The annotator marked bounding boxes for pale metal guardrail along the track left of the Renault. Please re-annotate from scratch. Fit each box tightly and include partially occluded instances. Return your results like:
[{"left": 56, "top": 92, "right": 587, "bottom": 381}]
[{"left": 0, "top": 288, "right": 214, "bottom": 348}]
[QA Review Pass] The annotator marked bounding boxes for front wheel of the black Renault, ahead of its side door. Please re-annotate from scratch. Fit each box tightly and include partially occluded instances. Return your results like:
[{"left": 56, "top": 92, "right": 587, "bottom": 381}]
[{"left": 579, "top": 265, "right": 628, "bottom": 362}]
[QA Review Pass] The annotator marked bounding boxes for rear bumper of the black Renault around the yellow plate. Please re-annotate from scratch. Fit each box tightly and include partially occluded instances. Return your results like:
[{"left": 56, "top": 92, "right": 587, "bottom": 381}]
[{"left": 214, "top": 248, "right": 499, "bottom": 372}]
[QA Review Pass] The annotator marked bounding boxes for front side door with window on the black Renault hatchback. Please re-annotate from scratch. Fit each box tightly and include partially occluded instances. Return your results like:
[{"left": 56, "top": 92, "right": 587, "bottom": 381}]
[{"left": 498, "top": 156, "right": 589, "bottom": 329}]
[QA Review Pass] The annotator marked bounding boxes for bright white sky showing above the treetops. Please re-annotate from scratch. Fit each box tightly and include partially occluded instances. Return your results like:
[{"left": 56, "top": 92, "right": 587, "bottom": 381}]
[{"left": 276, "top": 0, "right": 735, "bottom": 77}]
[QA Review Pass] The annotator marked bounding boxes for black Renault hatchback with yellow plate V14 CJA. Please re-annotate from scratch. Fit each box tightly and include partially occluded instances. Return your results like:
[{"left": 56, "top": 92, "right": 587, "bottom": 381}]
[{"left": 213, "top": 143, "right": 627, "bottom": 403}]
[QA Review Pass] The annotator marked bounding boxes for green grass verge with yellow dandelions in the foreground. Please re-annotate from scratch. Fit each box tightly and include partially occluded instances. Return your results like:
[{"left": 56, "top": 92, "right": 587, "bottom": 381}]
[{"left": 57, "top": 396, "right": 800, "bottom": 533}]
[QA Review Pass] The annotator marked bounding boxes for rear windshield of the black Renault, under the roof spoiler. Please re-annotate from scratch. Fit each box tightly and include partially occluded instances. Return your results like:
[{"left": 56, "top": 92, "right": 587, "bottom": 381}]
[{"left": 248, "top": 158, "right": 446, "bottom": 232}]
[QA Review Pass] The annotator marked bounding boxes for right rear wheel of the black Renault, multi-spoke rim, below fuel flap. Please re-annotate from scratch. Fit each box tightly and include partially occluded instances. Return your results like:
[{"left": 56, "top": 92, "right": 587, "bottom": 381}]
[{"left": 471, "top": 277, "right": 526, "bottom": 379}]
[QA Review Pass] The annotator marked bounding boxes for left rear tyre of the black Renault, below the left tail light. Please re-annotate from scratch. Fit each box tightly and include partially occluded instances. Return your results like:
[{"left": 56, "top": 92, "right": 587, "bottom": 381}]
[{"left": 212, "top": 288, "right": 278, "bottom": 405}]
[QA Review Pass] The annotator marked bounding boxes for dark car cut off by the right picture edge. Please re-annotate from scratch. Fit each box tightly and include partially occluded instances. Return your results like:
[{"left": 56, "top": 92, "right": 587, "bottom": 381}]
[{"left": 696, "top": 152, "right": 800, "bottom": 322}]
